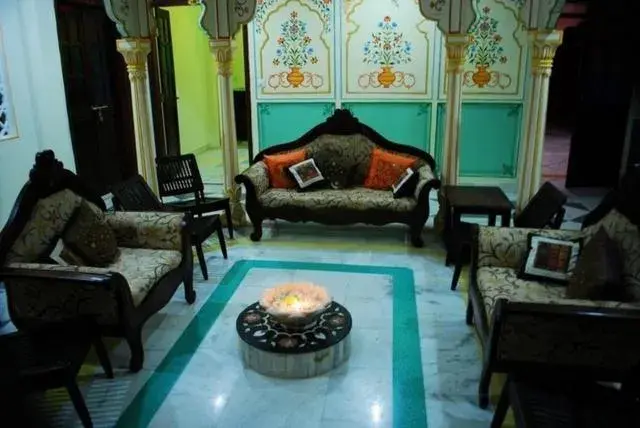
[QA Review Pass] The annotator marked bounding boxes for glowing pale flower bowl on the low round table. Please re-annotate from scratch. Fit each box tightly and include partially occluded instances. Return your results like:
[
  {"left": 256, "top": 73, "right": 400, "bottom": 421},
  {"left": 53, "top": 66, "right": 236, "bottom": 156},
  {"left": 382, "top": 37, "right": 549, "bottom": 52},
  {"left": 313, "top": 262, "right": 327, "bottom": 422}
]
[{"left": 260, "top": 283, "right": 332, "bottom": 328}]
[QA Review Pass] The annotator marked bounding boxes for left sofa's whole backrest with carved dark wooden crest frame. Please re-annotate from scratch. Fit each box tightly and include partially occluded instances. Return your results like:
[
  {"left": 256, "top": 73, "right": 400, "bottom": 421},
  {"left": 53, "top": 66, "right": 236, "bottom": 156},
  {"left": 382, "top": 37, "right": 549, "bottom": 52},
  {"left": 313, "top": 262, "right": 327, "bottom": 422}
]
[{"left": 0, "top": 150, "right": 106, "bottom": 266}]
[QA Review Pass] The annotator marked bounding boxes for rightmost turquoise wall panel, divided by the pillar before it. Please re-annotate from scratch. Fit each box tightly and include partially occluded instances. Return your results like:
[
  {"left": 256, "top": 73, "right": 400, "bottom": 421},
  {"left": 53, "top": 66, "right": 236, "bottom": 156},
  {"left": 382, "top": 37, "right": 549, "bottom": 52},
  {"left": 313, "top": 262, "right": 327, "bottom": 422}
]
[{"left": 434, "top": 103, "right": 522, "bottom": 178}]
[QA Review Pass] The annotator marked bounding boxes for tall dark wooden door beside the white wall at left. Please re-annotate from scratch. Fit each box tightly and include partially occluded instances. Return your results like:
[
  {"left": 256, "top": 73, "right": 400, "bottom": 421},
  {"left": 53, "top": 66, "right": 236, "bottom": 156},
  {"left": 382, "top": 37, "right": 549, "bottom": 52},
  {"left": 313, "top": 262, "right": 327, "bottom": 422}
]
[{"left": 56, "top": 0, "right": 135, "bottom": 193}]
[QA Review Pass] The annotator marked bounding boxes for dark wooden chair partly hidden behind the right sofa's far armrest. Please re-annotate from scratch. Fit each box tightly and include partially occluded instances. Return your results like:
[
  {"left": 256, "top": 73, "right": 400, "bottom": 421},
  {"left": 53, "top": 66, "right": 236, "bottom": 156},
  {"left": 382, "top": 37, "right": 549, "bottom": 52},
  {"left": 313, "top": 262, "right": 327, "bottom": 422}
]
[{"left": 451, "top": 181, "right": 567, "bottom": 290}]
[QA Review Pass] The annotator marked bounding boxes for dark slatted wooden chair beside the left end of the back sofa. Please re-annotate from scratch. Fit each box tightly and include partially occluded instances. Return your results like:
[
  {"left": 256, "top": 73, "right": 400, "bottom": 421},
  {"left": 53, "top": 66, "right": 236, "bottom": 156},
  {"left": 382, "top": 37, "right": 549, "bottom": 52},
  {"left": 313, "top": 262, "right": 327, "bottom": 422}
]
[{"left": 156, "top": 153, "right": 233, "bottom": 239}]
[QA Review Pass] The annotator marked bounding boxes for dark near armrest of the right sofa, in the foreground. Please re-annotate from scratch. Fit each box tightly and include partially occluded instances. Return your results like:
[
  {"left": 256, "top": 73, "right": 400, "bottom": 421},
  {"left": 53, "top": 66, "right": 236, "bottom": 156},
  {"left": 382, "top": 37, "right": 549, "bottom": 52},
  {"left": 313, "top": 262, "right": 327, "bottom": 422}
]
[{"left": 489, "top": 299, "right": 640, "bottom": 380}]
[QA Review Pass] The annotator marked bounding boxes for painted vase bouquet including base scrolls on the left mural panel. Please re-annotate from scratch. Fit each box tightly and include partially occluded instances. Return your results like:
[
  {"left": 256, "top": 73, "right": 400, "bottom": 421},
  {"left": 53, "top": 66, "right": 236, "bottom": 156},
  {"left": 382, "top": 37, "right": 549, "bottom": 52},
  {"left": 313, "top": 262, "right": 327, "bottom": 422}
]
[{"left": 269, "top": 10, "right": 324, "bottom": 89}]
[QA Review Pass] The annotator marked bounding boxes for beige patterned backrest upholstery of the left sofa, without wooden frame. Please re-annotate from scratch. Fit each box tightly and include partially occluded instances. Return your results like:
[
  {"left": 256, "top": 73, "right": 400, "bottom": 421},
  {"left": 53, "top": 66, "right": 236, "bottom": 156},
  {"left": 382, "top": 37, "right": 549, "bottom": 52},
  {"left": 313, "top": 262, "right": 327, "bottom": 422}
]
[{"left": 7, "top": 189, "right": 82, "bottom": 263}]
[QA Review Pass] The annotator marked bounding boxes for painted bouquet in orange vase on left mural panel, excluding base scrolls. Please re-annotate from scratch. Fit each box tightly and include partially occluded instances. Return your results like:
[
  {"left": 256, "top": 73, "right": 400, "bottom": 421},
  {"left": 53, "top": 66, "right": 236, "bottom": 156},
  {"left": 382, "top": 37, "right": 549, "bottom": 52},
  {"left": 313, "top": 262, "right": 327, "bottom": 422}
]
[{"left": 272, "top": 10, "right": 318, "bottom": 88}]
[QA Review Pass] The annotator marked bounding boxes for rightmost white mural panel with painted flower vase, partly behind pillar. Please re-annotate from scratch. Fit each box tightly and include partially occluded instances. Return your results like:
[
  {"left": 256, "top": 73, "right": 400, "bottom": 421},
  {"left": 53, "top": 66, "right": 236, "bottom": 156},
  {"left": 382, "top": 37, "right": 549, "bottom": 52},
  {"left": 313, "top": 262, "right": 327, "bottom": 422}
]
[{"left": 440, "top": 0, "right": 527, "bottom": 99}]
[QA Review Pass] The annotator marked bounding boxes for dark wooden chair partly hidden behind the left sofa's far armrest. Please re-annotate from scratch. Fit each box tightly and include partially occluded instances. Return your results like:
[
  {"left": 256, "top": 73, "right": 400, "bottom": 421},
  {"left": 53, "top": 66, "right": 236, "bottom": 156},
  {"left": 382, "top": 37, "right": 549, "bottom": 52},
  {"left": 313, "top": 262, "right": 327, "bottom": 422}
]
[{"left": 111, "top": 175, "right": 227, "bottom": 280}]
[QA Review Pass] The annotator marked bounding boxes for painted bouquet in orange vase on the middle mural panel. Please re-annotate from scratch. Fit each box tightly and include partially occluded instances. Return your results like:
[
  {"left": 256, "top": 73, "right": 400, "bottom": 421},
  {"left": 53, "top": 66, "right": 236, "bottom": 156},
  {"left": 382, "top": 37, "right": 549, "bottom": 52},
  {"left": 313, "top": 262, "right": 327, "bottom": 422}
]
[{"left": 363, "top": 16, "right": 412, "bottom": 88}]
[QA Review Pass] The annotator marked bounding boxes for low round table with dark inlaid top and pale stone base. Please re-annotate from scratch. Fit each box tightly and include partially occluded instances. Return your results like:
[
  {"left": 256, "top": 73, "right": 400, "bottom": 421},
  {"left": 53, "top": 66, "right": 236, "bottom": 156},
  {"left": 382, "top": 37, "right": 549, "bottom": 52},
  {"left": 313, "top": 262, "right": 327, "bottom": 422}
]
[{"left": 236, "top": 302, "right": 351, "bottom": 378}]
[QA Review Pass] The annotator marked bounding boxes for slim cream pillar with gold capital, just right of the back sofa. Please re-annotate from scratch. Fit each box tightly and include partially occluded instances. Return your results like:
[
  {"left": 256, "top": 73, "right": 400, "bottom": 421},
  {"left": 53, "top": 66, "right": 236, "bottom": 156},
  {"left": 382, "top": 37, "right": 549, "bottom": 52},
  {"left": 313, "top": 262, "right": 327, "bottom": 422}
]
[{"left": 435, "top": 33, "right": 469, "bottom": 231}]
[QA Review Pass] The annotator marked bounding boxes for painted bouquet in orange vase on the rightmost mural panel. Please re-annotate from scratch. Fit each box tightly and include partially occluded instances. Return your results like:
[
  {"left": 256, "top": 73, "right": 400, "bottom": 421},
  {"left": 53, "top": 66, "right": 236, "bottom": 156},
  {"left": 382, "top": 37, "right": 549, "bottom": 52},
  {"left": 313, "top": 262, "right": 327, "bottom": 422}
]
[{"left": 467, "top": 7, "right": 507, "bottom": 88}]
